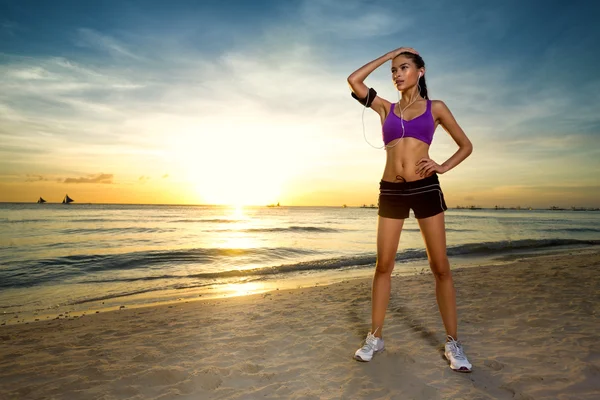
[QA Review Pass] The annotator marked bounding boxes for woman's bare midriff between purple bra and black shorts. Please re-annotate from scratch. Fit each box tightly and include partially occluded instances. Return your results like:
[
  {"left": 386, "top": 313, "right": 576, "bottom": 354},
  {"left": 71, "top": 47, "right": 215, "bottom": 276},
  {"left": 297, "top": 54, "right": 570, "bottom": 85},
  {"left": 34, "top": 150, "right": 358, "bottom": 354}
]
[{"left": 382, "top": 137, "right": 431, "bottom": 182}]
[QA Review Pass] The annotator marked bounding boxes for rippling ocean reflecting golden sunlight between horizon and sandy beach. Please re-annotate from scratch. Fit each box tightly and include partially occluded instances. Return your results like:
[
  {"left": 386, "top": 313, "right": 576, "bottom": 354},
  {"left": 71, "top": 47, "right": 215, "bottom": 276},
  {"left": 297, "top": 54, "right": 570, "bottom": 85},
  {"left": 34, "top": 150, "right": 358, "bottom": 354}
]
[{"left": 0, "top": 203, "right": 600, "bottom": 323}]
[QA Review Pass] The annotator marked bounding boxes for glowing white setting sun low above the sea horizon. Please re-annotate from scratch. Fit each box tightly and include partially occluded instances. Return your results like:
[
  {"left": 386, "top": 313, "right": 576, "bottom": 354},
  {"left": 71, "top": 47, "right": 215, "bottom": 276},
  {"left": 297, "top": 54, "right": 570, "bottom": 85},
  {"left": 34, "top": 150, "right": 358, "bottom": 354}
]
[{"left": 169, "top": 117, "right": 304, "bottom": 206}]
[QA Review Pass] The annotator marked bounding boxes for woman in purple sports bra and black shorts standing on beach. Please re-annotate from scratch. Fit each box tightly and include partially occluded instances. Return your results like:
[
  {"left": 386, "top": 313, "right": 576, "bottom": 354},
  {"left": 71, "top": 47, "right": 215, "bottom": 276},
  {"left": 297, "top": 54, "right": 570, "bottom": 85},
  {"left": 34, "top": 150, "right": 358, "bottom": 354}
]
[{"left": 348, "top": 47, "right": 473, "bottom": 372}]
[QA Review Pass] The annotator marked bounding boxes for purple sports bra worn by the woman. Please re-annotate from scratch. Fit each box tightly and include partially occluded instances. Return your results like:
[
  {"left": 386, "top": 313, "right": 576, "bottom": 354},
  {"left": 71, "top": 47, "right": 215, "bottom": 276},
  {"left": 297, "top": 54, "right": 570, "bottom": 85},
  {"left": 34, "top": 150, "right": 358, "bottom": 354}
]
[{"left": 382, "top": 100, "right": 435, "bottom": 145}]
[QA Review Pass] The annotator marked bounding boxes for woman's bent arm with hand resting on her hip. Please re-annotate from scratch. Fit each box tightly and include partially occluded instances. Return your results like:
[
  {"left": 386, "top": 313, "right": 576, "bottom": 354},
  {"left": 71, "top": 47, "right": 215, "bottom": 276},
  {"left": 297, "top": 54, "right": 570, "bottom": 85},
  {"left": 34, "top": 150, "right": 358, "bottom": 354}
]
[{"left": 416, "top": 100, "right": 473, "bottom": 176}]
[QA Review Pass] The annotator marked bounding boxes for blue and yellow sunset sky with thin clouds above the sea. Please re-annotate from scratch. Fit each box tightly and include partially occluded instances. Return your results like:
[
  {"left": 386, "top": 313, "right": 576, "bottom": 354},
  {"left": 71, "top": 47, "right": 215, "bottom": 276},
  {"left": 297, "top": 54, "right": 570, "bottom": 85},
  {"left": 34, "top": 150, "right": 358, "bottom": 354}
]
[{"left": 0, "top": 0, "right": 600, "bottom": 208}]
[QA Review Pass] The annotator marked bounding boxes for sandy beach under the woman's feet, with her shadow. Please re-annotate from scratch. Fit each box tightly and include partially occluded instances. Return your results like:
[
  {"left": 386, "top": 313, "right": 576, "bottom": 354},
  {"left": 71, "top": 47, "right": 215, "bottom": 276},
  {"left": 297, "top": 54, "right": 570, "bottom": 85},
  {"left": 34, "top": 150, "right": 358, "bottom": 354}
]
[{"left": 0, "top": 250, "right": 600, "bottom": 400}]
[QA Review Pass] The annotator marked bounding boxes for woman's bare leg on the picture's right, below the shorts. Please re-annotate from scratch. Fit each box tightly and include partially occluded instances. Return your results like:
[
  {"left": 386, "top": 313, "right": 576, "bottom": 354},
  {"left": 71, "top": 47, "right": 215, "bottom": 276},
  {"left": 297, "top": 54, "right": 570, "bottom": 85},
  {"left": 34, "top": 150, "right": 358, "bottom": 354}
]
[{"left": 418, "top": 213, "right": 458, "bottom": 340}]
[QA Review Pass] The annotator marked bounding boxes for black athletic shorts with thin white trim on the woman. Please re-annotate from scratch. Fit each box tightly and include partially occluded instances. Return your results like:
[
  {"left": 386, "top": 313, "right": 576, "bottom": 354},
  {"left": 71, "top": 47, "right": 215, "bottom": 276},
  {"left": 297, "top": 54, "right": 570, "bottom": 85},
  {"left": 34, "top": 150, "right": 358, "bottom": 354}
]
[{"left": 378, "top": 174, "right": 448, "bottom": 219}]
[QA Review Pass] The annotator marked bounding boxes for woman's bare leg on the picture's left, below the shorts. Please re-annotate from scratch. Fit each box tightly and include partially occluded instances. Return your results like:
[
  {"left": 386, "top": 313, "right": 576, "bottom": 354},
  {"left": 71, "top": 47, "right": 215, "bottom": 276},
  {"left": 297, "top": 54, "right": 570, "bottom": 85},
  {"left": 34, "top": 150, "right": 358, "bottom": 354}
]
[{"left": 371, "top": 217, "right": 404, "bottom": 337}]
